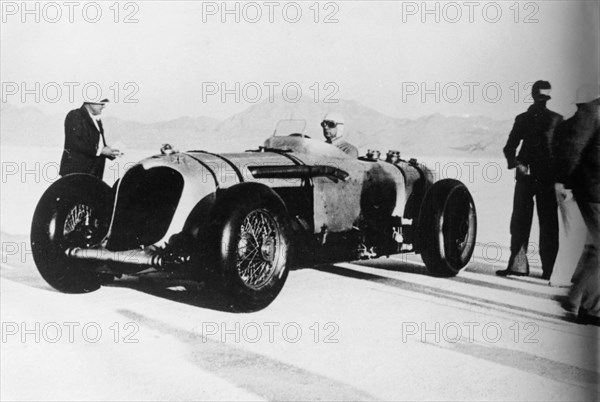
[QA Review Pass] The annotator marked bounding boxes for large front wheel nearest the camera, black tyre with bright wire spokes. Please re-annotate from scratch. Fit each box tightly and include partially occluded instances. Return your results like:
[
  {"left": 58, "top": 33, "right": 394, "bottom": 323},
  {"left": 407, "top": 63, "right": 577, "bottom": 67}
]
[{"left": 212, "top": 183, "right": 290, "bottom": 311}]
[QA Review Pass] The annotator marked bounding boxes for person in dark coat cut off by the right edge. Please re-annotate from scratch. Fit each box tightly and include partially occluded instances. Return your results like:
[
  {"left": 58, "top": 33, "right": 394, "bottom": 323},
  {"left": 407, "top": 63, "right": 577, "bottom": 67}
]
[{"left": 555, "top": 85, "right": 600, "bottom": 325}]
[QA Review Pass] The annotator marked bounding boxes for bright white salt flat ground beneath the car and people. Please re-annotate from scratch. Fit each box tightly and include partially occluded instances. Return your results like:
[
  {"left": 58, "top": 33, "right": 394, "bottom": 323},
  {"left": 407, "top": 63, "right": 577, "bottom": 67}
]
[{"left": 0, "top": 147, "right": 600, "bottom": 400}]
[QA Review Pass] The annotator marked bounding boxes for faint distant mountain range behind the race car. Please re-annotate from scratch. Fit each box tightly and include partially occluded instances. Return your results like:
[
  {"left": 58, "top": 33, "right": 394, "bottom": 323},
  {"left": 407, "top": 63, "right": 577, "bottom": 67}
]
[{"left": 0, "top": 98, "right": 512, "bottom": 157}]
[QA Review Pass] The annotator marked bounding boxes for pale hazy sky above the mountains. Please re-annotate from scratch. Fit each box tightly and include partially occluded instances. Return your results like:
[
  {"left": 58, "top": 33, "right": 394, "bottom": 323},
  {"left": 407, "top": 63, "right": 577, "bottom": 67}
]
[{"left": 0, "top": 1, "right": 600, "bottom": 121}]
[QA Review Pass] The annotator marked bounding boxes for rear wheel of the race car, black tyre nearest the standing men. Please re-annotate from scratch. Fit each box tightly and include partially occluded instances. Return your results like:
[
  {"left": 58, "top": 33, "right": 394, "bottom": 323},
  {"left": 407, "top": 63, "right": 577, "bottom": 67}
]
[{"left": 418, "top": 179, "right": 477, "bottom": 276}]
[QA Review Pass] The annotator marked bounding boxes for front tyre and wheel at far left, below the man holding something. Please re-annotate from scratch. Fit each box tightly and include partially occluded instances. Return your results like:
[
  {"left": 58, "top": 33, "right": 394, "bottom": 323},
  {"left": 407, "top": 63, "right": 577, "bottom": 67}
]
[{"left": 31, "top": 174, "right": 112, "bottom": 293}]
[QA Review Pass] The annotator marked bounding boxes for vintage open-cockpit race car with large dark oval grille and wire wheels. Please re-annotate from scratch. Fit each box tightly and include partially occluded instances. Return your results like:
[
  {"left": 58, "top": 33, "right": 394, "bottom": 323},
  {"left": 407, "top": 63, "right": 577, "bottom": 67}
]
[{"left": 31, "top": 127, "right": 477, "bottom": 309}]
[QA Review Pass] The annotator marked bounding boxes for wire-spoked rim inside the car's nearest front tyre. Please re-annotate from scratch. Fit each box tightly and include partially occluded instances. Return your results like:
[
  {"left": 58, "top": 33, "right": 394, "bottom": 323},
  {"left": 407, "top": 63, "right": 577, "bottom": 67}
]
[{"left": 236, "top": 209, "right": 281, "bottom": 289}]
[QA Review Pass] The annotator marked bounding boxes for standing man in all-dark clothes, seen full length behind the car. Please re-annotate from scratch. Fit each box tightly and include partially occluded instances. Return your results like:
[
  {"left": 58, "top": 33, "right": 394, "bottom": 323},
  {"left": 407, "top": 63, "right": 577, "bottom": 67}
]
[{"left": 496, "top": 81, "right": 562, "bottom": 279}]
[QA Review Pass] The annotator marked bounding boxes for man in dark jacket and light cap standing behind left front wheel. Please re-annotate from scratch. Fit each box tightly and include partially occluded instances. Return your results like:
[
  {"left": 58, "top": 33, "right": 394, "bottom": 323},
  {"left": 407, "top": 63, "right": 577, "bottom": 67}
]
[{"left": 59, "top": 99, "right": 121, "bottom": 179}]
